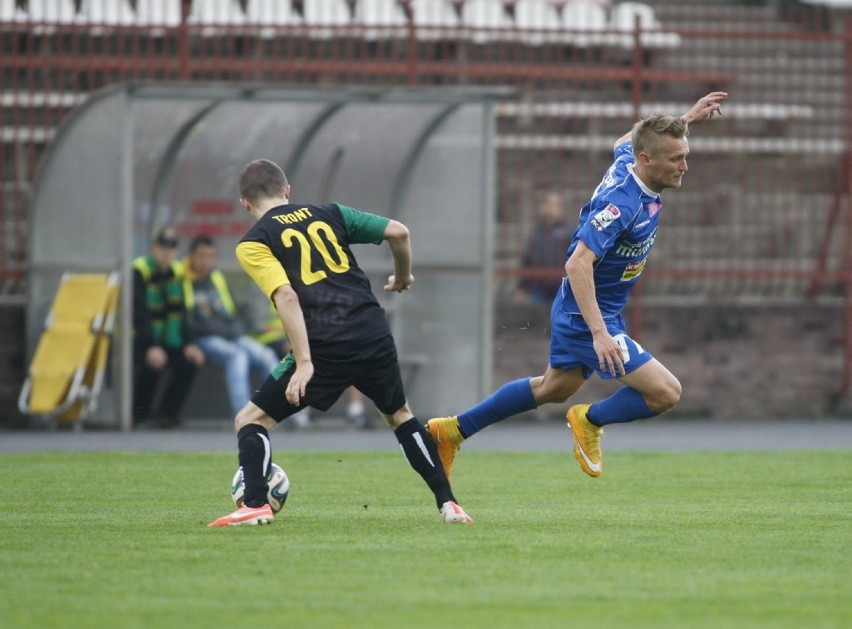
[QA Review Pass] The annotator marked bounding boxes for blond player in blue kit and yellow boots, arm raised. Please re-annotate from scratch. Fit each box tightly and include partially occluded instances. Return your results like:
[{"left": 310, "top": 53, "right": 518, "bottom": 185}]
[{"left": 428, "top": 92, "right": 728, "bottom": 478}]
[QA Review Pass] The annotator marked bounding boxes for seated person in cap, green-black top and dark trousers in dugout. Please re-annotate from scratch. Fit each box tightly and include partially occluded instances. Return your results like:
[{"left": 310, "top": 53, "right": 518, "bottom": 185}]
[{"left": 133, "top": 227, "right": 204, "bottom": 428}]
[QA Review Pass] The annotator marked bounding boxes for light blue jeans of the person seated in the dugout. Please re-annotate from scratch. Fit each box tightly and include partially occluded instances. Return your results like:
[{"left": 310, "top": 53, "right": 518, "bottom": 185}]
[{"left": 195, "top": 335, "right": 278, "bottom": 416}]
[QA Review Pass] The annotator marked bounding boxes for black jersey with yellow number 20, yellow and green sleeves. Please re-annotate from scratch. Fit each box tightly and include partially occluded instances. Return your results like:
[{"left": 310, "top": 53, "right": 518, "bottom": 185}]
[{"left": 236, "top": 203, "right": 390, "bottom": 351}]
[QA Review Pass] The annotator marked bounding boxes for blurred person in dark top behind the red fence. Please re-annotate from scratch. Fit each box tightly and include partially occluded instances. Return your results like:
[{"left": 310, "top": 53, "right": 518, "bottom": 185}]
[{"left": 517, "top": 192, "right": 572, "bottom": 303}]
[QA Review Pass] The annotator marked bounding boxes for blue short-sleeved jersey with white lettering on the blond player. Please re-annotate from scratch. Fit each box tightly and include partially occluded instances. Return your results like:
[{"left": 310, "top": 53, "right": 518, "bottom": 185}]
[{"left": 560, "top": 142, "right": 662, "bottom": 319}]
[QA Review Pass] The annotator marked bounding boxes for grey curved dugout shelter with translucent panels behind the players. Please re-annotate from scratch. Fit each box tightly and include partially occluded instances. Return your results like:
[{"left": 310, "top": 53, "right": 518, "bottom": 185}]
[{"left": 27, "top": 84, "right": 506, "bottom": 429}]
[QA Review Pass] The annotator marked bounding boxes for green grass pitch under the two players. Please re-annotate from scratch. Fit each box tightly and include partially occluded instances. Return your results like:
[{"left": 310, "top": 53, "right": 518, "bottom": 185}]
[{"left": 0, "top": 451, "right": 852, "bottom": 629}]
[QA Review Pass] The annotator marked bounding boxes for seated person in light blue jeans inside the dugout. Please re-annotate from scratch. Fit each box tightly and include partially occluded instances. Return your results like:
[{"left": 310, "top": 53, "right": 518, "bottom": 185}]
[{"left": 183, "top": 235, "right": 279, "bottom": 415}]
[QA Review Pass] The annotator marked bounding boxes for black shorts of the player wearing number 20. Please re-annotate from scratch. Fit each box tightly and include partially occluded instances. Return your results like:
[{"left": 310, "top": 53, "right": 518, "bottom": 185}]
[{"left": 251, "top": 336, "right": 405, "bottom": 422}]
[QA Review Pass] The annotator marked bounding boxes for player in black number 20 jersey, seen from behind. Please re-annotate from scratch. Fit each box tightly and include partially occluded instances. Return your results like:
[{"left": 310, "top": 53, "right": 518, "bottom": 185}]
[{"left": 209, "top": 159, "right": 473, "bottom": 526}]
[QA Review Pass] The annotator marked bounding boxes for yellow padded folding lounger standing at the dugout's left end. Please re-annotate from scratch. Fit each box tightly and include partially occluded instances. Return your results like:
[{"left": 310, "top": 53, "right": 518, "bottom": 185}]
[{"left": 18, "top": 273, "right": 118, "bottom": 421}]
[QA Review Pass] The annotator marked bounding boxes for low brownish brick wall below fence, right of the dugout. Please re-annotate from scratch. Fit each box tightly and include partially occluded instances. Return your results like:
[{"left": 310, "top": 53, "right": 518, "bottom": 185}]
[{"left": 493, "top": 304, "right": 852, "bottom": 419}]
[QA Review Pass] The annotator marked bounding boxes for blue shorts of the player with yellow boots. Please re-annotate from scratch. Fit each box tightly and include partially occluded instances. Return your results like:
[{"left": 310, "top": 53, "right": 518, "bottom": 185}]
[{"left": 550, "top": 297, "right": 654, "bottom": 380}]
